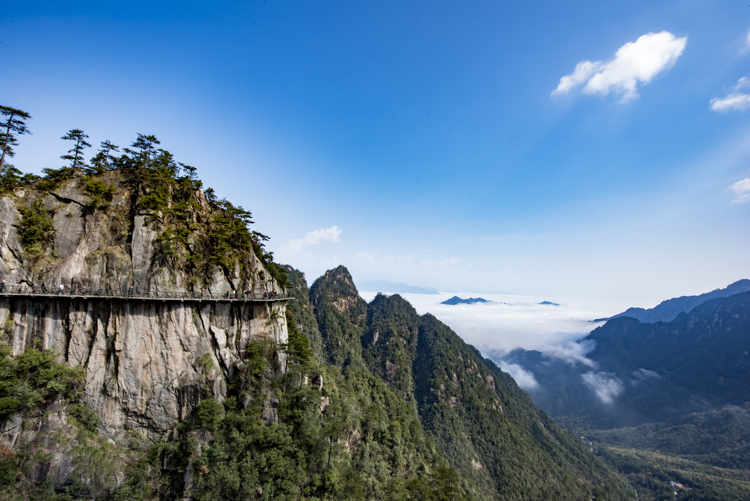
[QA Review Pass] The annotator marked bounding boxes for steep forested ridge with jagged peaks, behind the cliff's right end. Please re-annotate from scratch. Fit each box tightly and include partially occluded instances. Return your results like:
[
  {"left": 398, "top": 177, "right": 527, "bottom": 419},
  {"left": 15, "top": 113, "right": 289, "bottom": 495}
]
[{"left": 310, "top": 267, "right": 629, "bottom": 499}]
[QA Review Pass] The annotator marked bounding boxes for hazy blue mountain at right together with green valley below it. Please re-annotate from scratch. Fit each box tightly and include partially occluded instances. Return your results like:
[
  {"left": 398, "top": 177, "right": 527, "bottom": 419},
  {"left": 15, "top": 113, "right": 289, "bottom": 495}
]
[{"left": 495, "top": 283, "right": 750, "bottom": 494}]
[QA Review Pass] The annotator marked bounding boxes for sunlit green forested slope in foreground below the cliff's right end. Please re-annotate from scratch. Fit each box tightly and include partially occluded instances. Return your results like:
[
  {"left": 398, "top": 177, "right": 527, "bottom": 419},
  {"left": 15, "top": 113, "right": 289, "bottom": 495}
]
[{"left": 143, "top": 334, "right": 464, "bottom": 500}]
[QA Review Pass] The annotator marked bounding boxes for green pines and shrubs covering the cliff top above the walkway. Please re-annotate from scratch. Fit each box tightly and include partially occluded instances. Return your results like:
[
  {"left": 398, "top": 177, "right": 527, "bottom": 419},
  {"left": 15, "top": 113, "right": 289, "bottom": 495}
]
[{"left": 0, "top": 121, "right": 286, "bottom": 289}]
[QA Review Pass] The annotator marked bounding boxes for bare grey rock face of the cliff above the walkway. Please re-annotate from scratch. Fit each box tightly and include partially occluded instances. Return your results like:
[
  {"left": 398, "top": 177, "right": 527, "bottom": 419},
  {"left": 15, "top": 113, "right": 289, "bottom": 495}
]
[{"left": 0, "top": 172, "right": 280, "bottom": 296}]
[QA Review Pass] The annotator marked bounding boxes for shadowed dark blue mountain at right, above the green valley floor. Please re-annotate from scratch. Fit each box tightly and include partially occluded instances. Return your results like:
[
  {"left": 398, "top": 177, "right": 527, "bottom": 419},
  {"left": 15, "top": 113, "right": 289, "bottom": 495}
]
[{"left": 499, "top": 292, "right": 750, "bottom": 427}]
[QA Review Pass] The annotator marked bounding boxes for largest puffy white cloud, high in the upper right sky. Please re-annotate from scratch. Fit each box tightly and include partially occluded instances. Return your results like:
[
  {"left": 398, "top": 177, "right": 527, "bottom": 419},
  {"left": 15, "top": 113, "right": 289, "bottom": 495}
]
[{"left": 552, "top": 31, "right": 687, "bottom": 101}]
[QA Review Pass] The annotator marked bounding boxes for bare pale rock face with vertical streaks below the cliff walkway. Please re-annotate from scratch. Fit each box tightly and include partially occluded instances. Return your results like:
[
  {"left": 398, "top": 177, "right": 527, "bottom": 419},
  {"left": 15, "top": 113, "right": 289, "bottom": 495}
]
[{"left": 0, "top": 296, "right": 286, "bottom": 437}]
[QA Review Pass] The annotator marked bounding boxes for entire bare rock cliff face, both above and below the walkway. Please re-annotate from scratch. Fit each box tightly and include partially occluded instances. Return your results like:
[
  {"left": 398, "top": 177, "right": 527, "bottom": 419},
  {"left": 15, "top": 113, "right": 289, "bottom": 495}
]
[{"left": 0, "top": 172, "right": 287, "bottom": 447}]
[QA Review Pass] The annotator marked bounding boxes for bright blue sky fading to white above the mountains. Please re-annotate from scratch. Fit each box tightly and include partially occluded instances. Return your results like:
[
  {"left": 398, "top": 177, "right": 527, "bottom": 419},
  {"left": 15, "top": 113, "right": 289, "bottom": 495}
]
[{"left": 0, "top": 1, "right": 750, "bottom": 311}]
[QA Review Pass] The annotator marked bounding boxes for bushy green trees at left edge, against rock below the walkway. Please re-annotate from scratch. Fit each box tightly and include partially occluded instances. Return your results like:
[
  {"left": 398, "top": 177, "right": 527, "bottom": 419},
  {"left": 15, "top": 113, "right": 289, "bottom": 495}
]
[{"left": 0, "top": 345, "right": 85, "bottom": 422}]
